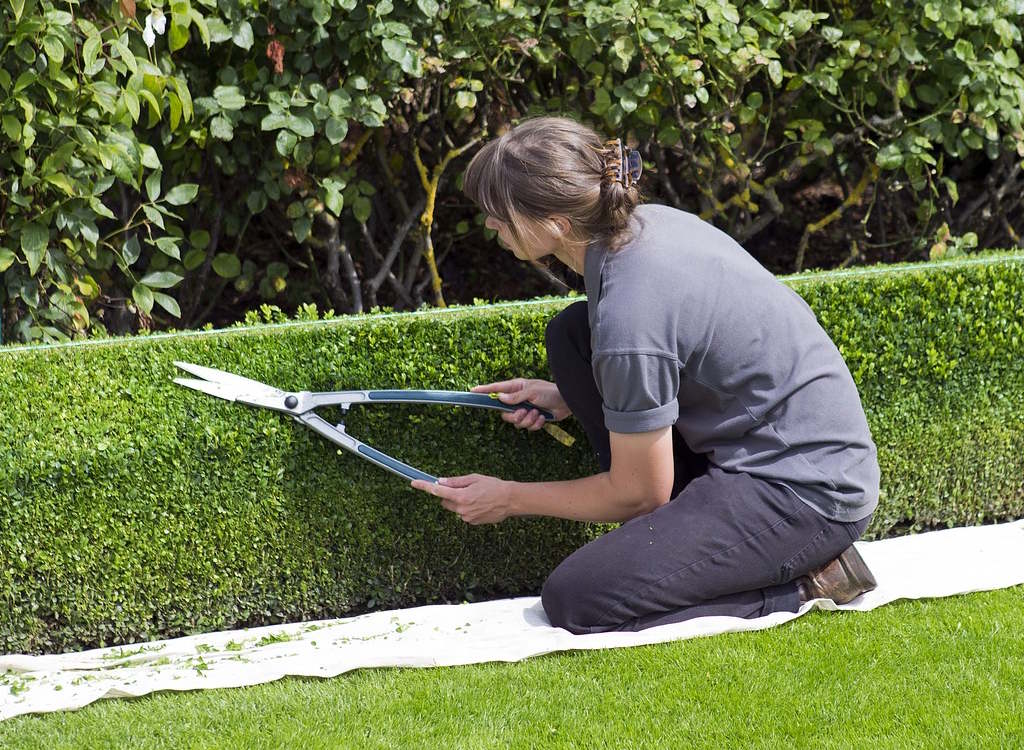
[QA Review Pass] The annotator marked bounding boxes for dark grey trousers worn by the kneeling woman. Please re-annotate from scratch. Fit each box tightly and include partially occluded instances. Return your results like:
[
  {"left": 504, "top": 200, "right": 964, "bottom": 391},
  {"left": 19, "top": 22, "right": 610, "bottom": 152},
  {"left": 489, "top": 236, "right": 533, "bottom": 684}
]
[{"left": 541, "top": 302, "right": 870, "bottom": 633}]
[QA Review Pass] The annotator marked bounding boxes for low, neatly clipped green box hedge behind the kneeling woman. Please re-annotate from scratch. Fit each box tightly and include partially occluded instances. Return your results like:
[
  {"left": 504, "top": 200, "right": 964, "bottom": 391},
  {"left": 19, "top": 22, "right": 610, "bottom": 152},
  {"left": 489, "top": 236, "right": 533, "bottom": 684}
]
[{"left": 0, "top": 248, "right": 1024, "bottom": 652}]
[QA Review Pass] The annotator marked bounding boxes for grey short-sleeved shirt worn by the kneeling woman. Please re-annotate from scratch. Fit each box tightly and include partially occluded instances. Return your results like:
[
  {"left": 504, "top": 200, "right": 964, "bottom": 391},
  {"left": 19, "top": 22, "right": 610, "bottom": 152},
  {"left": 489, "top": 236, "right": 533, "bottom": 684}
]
[{"left": 584, "top": 205, "right": 880, "bottom": 522}]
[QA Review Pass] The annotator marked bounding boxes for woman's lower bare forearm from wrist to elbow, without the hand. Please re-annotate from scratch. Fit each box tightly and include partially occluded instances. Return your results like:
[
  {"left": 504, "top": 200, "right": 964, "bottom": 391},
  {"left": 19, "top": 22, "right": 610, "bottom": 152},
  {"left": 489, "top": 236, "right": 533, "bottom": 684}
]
[{"left": 501, "top": 471, "right": 659, "bottom": 523}]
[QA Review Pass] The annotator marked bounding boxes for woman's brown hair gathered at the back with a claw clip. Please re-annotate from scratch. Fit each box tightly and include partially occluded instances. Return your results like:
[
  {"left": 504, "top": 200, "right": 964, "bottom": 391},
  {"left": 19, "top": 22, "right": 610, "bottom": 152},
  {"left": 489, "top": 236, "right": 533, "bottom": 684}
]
[{"left": 463, "top": 117, "right": 641, "bottom": 248}]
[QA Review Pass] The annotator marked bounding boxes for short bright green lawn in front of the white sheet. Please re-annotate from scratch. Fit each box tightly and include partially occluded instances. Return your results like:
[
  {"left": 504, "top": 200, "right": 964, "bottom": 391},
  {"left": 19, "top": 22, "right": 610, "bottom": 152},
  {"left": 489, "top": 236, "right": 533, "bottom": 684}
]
[{"left": 0, "top": 586, "right": 1024, "bottom": 750}]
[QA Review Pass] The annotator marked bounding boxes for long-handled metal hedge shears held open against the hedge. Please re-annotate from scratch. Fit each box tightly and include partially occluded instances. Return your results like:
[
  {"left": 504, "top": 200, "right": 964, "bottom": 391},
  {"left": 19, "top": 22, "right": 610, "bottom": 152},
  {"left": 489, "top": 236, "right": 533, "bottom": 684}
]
[{"left": 174, "top": 362, "right": 561, "bottom": 483}]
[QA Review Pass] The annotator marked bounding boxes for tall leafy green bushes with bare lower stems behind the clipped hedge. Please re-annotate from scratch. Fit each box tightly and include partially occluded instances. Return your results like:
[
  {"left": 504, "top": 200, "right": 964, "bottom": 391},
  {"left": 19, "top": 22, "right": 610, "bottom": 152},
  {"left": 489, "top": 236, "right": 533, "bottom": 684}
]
[{"left": 0, "top": 0, "right": 1024, "bottom": 341}]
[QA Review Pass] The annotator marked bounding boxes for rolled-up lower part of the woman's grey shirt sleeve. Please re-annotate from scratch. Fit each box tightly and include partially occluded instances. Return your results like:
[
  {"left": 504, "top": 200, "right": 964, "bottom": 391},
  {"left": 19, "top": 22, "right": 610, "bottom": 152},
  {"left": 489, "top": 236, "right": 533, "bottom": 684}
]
[{"left": 593, "top": 351, "right": 679, "bottom": 432}]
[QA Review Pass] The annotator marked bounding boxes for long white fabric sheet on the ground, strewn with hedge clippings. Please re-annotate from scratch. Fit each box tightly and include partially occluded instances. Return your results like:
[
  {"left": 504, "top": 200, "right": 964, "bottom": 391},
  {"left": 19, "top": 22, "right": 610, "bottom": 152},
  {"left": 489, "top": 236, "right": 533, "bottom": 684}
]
[{"left": 0, "top": 520, "right": 1024, "bottom": 719}]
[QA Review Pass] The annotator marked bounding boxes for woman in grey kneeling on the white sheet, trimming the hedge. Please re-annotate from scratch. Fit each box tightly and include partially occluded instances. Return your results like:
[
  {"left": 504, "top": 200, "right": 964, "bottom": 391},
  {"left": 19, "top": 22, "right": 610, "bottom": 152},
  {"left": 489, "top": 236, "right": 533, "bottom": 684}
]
[{"left": 413, "top": 117, "right": 879, "bottom": 633}]
